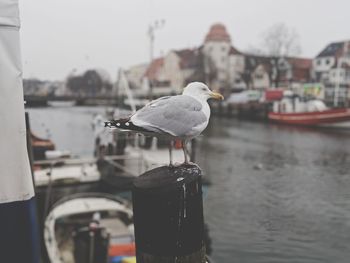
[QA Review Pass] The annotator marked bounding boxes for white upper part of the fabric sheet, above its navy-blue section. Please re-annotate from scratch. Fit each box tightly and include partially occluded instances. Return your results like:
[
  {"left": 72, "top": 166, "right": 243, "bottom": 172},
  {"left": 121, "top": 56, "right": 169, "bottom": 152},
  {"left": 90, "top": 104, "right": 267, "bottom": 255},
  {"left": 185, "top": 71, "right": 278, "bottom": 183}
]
[{"left": 0, "top": 0, "right": 34, "bottom": 203}]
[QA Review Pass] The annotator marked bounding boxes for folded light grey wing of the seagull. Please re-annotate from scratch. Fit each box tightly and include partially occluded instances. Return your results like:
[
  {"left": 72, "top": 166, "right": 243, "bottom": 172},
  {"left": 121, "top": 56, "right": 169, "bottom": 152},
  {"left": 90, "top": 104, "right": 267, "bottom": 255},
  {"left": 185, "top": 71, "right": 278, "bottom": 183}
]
[{"left": 131, "top": 95, "right": 207, "bottom": 137}]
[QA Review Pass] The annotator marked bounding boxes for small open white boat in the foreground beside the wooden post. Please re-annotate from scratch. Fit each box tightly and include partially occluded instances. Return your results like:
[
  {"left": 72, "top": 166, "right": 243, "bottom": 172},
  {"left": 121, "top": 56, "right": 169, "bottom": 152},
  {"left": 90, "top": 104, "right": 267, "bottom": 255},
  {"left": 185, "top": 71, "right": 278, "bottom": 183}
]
[{"left": 44, "top": 193, "right": 136, "bottom": 263}]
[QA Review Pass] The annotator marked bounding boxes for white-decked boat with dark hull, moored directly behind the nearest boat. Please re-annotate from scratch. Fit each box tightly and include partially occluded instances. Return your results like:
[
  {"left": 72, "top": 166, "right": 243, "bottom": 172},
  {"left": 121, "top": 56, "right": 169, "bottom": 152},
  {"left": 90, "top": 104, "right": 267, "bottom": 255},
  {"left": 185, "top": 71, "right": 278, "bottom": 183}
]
[{"left": 33, "top": 156, "right": 140, "bottom": 225}]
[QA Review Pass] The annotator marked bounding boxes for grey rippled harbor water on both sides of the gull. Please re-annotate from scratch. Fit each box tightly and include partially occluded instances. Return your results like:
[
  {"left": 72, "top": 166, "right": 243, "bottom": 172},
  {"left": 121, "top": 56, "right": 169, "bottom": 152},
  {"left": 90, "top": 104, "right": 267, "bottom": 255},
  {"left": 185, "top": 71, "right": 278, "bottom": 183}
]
[{"left": 28, "top": 107, "right": 350, "bottom": 263}]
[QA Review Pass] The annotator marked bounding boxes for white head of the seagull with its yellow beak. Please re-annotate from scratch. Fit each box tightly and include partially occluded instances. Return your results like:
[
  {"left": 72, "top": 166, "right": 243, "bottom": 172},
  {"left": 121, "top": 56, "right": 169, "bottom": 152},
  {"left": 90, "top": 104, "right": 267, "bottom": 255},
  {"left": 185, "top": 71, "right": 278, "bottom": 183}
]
[{"left": 182, "top": 82, "right": 224, "bottom": 100}]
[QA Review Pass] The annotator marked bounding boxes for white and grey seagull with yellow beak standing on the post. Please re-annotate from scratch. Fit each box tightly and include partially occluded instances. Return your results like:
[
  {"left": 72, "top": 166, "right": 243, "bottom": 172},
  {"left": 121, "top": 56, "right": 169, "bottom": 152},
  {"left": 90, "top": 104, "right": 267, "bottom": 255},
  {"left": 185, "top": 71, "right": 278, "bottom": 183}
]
[{"left": 105, "top": 82, "right": 224, "bottom": 166}]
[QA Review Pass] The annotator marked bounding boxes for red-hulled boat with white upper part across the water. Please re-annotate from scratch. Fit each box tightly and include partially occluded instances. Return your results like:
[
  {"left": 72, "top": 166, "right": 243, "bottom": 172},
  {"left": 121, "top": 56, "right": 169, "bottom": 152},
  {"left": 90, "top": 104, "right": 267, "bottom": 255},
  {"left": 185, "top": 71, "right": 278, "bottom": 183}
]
[{"left": 268, "top": 91, "right": 350, "bottom": 128}]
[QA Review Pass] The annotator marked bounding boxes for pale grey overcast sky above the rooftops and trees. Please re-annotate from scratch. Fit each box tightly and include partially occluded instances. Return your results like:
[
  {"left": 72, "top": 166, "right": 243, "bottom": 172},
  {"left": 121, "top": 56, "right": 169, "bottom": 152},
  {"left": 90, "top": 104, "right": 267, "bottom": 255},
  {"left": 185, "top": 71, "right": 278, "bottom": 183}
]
[{"left": 20, "top": 0, "right": 350, "bottom": 80}]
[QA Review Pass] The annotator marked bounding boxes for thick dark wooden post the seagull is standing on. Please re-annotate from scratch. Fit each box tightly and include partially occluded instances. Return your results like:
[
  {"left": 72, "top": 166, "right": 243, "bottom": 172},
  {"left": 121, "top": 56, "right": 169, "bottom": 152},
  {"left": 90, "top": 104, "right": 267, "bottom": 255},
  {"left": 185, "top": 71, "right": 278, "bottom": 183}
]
[{"left": 132, "top": 165, "right": 206, "bottom": 263}]
